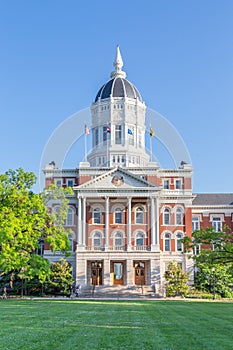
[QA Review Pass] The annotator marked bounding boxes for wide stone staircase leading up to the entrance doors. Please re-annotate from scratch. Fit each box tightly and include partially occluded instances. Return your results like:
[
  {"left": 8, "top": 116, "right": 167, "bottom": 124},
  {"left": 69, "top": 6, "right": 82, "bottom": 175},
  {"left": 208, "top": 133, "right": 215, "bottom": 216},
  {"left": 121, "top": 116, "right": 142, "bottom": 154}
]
[{"left": 76, "top": 285, "right": 161, "bottom": 299}]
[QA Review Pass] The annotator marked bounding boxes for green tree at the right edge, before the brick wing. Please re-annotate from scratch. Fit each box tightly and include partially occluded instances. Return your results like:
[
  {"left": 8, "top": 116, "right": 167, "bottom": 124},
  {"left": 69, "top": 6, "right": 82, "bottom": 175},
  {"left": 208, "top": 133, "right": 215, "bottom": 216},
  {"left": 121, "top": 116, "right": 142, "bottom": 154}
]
[{"left": 182, "top": 226, "right": 233, "bottom": 297}]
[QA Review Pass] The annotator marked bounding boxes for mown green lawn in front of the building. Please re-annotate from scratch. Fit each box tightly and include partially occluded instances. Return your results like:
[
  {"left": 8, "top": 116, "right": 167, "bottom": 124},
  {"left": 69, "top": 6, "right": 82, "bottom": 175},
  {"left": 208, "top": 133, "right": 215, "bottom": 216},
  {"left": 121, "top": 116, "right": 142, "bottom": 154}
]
[{"left": 0, "top": 300, "right": 233, "bottom": 350}]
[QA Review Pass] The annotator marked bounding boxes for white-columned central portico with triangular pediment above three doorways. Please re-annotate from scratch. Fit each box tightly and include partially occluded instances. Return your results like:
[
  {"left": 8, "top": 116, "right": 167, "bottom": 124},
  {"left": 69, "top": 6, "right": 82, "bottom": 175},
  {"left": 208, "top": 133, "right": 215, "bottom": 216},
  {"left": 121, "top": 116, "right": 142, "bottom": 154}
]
[{"left": 74, "top": 167, "right": 161, "bottom": 285}]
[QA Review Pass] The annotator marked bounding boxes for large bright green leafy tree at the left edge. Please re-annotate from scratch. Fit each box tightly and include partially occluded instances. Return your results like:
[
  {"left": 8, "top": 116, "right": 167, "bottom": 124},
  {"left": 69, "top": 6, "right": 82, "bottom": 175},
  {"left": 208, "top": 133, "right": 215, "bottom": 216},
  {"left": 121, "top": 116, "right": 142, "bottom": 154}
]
[{"left": 0, "top": 168, "right": 71, "bottom": 294}]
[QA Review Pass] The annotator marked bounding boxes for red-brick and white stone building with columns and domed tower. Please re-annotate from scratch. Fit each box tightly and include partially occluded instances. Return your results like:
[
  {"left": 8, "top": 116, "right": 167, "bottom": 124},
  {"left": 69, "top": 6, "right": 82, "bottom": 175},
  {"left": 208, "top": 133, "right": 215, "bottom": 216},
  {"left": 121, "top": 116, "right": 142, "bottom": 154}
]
[{"left": 44, "top": 47, "right": 233, "bottom": 297}]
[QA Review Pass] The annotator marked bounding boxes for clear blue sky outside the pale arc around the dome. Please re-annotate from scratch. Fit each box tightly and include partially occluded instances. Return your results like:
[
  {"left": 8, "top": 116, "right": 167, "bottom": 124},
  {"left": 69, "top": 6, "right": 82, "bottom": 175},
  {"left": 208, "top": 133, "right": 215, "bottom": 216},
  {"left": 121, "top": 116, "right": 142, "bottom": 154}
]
[{"left": 0, "top": 0, "right": 233, "bottom": 192}]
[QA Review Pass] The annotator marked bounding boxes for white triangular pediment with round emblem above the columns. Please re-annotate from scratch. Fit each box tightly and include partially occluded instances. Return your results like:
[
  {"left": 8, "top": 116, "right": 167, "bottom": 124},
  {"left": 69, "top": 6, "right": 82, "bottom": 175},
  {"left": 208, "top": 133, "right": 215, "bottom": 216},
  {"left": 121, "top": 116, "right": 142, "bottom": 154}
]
[{"left": 74, "top": 168, "right": 159, "bottom": 191}]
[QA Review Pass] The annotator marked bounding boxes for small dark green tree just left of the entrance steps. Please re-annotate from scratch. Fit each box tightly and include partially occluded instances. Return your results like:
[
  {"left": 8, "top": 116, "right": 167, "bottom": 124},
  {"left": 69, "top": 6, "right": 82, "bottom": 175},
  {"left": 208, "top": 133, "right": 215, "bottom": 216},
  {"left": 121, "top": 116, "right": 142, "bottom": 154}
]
[{"left": 46, "top": 259, "right": 74, "bottom": 295}]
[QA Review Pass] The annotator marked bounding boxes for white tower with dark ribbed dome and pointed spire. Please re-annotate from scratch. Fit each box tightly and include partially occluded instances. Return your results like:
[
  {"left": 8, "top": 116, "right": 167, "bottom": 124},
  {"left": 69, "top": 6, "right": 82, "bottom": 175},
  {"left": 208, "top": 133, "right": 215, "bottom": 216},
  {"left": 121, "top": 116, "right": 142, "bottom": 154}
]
[{"left": 88, "top": 47, "right": 149, "bottom": 167}]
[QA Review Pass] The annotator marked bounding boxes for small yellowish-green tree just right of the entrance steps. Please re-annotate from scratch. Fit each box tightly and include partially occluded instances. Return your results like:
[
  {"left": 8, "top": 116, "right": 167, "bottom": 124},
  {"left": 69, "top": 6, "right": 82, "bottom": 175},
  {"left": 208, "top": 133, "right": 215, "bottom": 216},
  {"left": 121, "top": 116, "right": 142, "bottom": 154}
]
[{"left": 165, "top": 261, "right": 190, "bottom": 297}]
